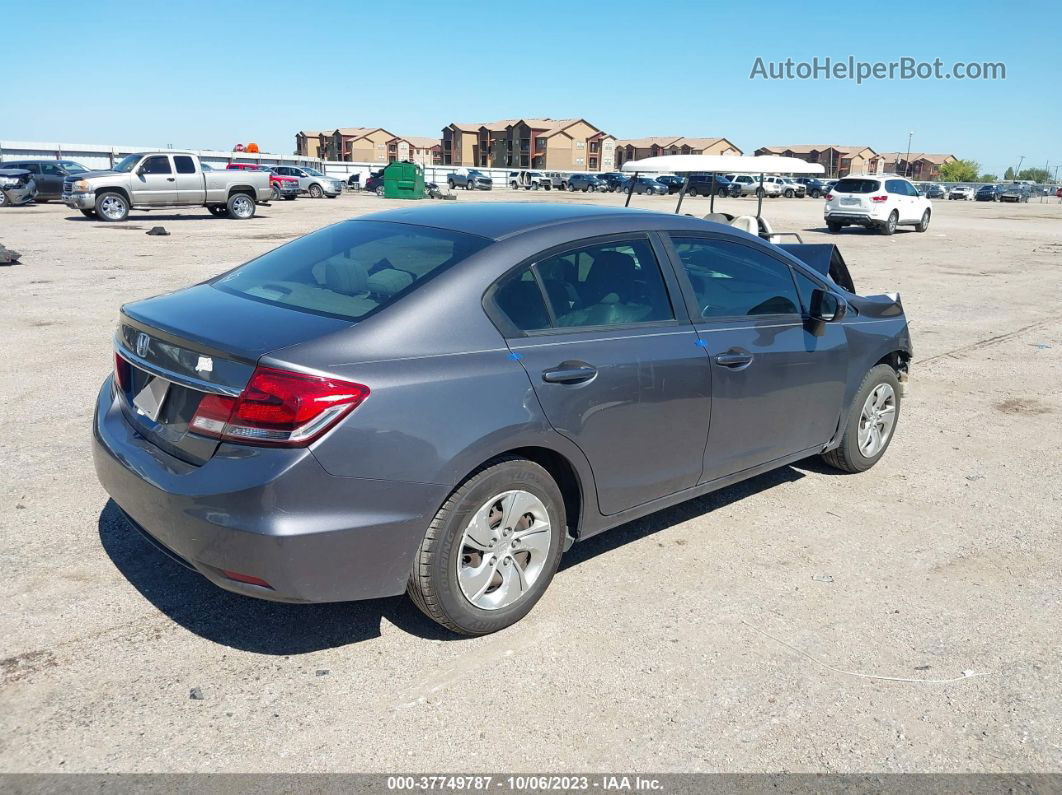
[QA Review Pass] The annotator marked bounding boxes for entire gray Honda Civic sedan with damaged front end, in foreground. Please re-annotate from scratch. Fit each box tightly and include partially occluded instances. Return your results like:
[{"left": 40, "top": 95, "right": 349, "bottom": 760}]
[{"left": 92, "top": 204, "right": 911, "bottom": 635}]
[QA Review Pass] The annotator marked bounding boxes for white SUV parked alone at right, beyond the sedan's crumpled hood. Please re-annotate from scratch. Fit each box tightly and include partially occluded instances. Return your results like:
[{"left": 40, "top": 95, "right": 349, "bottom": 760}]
[{"left": 823, "top": 176, "right": 932, "bottom": 235}]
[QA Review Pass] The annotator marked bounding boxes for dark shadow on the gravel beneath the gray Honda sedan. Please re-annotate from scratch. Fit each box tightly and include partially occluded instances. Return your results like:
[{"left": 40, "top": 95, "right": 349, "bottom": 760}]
[{"left": 98, "top": 467, "right": 805, "bottom": 655}]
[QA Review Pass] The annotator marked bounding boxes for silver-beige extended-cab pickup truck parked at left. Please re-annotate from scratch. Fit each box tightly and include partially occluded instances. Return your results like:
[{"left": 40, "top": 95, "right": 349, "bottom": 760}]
[{"left": 63, "top": 150, "right": 272, "bottom": 221}]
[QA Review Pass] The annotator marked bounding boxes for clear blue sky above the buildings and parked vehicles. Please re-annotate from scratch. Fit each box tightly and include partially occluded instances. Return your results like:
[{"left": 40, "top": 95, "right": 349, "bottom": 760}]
[{"left": 8, "top": 0, "right": 1062, "bottom": 174}]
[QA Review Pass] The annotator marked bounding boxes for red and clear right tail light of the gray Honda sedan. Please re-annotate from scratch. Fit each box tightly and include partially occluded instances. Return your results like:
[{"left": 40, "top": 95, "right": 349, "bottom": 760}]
[{"left": 188, "top": 367, "right": 369, "bottom": 447}]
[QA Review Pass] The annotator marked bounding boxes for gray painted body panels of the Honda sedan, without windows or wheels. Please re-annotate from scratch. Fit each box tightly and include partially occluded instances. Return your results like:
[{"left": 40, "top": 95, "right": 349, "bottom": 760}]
[{"left": 95, "top": 204, "right": 910, "bottom": 601}]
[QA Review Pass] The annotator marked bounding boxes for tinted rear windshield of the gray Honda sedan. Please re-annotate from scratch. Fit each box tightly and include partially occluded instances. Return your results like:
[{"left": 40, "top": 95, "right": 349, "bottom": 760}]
[{"left": 211, "top": 221, "right": 491, "bottom": 321}]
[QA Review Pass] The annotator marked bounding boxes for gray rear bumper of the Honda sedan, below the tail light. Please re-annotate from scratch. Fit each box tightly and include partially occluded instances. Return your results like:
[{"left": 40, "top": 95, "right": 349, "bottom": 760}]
[{"left": 92, "top": 378, "right": 447, "bottom": 602}]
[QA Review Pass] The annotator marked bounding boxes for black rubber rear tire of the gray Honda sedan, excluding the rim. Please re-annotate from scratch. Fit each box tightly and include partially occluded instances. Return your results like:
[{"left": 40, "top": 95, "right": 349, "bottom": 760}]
[{"left": 407, "top": 456, "right": 566, "bottom": 635}]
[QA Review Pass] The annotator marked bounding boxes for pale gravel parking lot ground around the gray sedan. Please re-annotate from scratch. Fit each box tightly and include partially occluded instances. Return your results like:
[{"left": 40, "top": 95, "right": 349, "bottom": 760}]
[{"left": 0, "top": 190, "right": 1062, "bottom": 772}]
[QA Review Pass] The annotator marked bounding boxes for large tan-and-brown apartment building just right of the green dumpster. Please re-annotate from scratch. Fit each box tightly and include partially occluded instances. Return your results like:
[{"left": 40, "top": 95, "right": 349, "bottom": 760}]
[{"left": 441, "top": 119, "right": 616, "bottom": 171}]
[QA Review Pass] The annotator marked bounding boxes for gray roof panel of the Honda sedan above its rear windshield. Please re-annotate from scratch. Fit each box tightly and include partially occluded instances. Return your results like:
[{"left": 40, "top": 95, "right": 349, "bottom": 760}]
[{"left": 354, "top": 202, "right": 716, "bottom": 240}]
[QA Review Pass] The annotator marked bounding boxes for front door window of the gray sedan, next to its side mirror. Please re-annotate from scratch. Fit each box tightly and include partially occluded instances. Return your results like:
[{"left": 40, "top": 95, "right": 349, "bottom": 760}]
[{"left": 671, "top": 237, "right": 801, "bottom": 319}]
